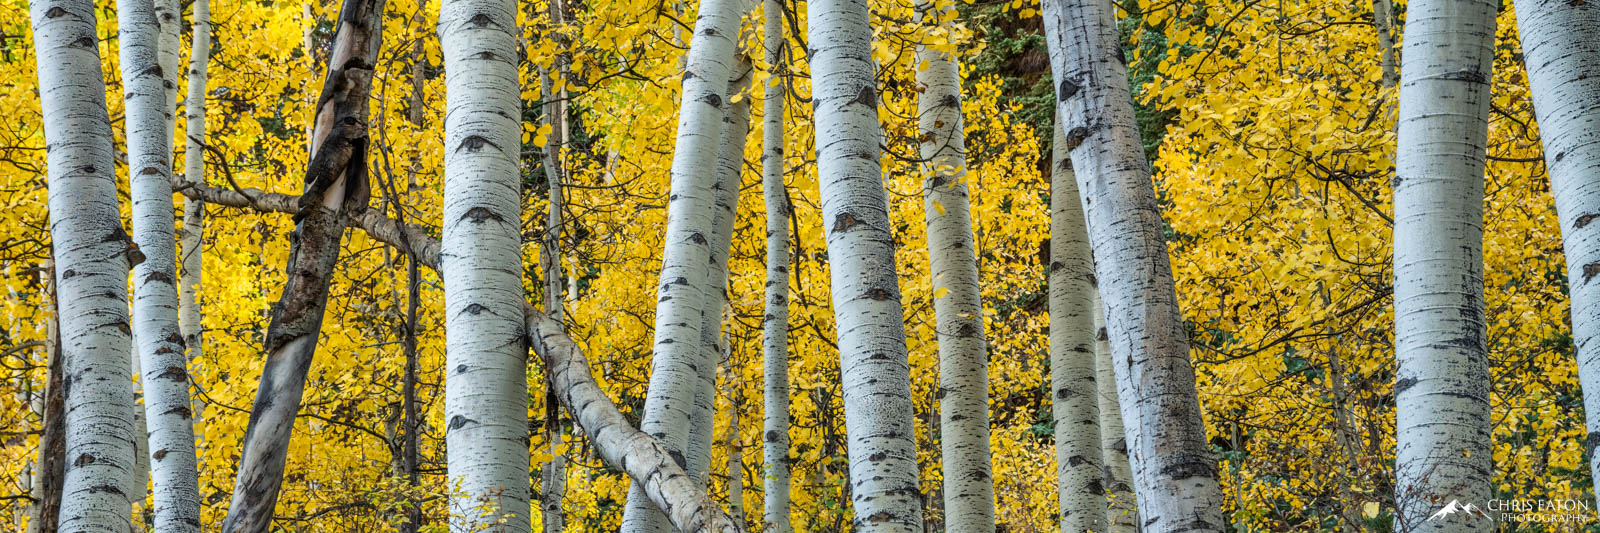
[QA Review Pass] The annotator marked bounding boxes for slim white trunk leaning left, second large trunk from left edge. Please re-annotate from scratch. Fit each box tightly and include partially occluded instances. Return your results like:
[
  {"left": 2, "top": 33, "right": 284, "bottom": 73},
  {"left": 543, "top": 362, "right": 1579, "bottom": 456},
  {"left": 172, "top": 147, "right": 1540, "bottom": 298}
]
[{"left": 117, "top": 0, "right": 200, "bottom": 524}]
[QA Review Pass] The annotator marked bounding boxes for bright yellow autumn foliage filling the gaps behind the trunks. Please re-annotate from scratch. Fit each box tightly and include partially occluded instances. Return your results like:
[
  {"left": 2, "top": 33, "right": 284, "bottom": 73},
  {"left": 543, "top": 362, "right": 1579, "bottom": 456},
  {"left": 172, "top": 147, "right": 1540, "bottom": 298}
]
[{"left": 0, "top": 0, "right": 1574, "bottom": 531}]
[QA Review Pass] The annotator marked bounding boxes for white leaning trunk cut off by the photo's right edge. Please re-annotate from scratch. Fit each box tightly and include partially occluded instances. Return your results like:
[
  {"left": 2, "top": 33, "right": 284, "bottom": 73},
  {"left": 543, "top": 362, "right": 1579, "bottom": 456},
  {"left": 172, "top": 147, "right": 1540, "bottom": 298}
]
[{"left": 1517, "top": 0, "right": 1600, "bottom": 512}]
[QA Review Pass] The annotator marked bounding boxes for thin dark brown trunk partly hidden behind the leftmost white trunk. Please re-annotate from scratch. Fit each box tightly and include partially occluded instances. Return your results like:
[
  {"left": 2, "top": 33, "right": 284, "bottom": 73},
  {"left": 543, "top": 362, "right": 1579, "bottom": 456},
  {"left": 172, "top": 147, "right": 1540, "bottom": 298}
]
[{"left": 27, "top": 261, "right": 67, "bottom": 533}]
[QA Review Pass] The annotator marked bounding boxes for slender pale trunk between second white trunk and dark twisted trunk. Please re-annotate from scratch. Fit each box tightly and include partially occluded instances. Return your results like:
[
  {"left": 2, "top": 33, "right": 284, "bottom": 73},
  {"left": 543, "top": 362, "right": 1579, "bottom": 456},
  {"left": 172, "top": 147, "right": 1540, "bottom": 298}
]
[{"left": 178, "top": 0, "right": 211, "bottom": 448}]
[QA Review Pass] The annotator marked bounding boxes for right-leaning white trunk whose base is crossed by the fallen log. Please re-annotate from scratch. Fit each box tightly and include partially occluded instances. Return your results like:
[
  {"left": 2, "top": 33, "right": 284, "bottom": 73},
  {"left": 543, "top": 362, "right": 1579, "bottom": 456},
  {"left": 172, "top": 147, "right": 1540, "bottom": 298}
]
[{"left": 622, "top": 0, "right": 739, "bottom": 524}]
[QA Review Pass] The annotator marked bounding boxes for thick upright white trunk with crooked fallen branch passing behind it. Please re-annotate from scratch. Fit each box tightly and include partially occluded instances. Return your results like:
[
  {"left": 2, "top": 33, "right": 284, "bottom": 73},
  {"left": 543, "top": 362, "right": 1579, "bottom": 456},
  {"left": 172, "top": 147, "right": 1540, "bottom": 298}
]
[{"left": 438, "top": 0, "right": 531, "bottom": 531}]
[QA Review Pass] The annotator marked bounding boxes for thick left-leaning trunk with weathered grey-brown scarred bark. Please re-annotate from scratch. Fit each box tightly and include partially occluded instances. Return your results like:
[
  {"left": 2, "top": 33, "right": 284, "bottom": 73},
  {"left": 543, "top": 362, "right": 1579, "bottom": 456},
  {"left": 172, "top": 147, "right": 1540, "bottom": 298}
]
[{"left": 1042, "top": 0, "right": 1226, "bottom": 533}]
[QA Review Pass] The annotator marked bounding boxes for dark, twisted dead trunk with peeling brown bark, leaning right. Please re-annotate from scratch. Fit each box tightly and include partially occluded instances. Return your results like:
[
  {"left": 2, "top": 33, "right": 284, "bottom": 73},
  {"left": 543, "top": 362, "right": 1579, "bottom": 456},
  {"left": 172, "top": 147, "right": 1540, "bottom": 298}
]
[{"left": 222, "top": 0, "right": 384, "bottom": 533}]
